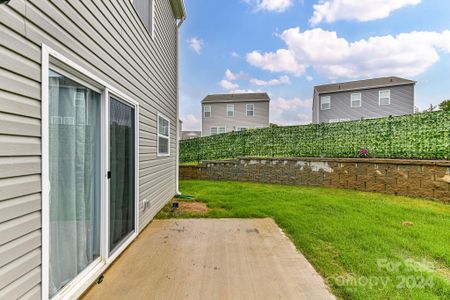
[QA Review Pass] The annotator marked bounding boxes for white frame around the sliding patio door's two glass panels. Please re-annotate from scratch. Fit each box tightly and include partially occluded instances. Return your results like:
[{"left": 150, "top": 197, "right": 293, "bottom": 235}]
[{"left": 41, "top": 44, "right": 139, "bottom": 300}]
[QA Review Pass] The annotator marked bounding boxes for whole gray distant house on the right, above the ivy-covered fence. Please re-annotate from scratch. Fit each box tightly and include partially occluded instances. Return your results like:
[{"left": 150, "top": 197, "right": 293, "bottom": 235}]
[{"left": 312, "top": 77, "right": 416, "bottom": 124}]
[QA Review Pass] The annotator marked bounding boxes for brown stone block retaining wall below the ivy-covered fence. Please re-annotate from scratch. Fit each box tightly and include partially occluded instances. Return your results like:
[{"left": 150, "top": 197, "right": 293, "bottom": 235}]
[{"left": 180, "top": 157, "right": 450, "bottom": 203}]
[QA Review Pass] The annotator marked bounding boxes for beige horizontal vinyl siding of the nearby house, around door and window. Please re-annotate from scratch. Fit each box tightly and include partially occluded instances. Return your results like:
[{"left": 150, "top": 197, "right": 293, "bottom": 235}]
[{"left": 0, "top": 0, "right": 178, "bottom": 299}]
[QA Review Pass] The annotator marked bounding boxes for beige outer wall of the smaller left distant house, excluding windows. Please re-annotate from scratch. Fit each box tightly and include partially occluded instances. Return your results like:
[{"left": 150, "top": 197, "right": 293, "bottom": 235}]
[{"left": 202, "top": 101, "right": 269, "bottom": 136}]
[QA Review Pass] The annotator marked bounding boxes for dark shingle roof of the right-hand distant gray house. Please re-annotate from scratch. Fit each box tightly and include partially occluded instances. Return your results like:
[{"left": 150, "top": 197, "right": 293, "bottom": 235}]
[{"left": 314, "top": 76, "right": 416, "bottom": 94}]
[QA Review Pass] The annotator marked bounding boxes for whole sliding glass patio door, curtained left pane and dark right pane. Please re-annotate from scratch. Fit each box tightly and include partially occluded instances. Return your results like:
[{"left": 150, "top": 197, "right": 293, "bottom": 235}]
[{"left": 47, "top": 63, "right": 138, "bottom": 299}]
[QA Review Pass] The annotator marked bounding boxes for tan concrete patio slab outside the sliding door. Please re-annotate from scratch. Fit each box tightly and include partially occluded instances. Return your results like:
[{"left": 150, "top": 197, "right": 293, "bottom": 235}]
[{"left": 84, "top": 219, "right": 334, "bottom": 300}]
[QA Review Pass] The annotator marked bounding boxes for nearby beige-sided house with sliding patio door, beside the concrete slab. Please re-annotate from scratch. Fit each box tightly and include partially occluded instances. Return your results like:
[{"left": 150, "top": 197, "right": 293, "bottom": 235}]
[{"left": 0, "top": 0, "right": 185, "bottom": 299}]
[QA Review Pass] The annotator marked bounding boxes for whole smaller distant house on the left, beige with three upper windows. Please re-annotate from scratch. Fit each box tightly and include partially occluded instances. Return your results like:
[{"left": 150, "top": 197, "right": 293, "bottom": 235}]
[{"left": 202, "top": 93, "right": 270, "bottom": 136}]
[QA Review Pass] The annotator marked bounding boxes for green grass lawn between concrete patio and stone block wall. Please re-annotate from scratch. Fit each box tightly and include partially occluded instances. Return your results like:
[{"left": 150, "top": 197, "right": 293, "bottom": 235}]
[{"left": 158, "top": 181, "right": 450, "bottom": 299}]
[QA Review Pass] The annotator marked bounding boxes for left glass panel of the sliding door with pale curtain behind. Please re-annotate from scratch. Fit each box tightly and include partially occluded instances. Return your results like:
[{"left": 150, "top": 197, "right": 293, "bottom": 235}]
[{"left": 49, "top": 71, "right": 101, "bottom": 297}]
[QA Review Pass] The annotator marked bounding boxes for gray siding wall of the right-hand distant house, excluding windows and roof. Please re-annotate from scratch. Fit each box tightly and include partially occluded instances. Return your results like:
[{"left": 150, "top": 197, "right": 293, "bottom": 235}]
[{"left": 313, "top": 84, "right": 414, "bottom": 124}]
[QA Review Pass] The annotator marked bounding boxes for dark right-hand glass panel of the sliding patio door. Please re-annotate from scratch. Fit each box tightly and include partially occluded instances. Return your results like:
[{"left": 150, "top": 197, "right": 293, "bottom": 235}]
[{"left": 109, "top": 98, "right": 136, "bottom": 252}]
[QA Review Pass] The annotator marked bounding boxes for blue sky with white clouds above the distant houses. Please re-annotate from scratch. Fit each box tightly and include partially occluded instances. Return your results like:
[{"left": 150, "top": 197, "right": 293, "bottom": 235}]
[{"left": 180, "top": 0, "right": 450, "bottom": 130}]
